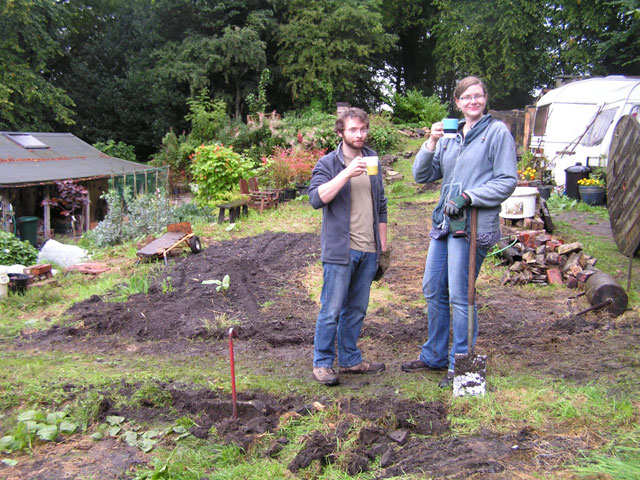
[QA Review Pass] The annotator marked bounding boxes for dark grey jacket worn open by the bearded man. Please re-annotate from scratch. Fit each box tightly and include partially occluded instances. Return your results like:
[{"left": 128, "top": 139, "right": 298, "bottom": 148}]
[{"left": 309, "top": 142, "right": 387, "bottom": 265}]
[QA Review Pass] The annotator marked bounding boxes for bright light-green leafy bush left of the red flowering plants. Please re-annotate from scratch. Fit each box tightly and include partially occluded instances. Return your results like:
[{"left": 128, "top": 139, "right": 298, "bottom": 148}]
[{"left": 189, "top": 143, "right": 254, "bottom": 205}]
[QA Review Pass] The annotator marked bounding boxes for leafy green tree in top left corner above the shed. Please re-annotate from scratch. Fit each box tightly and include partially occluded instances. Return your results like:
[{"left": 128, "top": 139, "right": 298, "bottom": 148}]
[{"left": 0, "top": 0, "right": 74, "bottom": 131}]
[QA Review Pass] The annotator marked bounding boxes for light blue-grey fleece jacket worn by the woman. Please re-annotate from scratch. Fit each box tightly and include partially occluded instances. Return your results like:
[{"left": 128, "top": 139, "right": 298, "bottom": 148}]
[{"left": 413, "top": 115, "right": 518, "bottom": 238}]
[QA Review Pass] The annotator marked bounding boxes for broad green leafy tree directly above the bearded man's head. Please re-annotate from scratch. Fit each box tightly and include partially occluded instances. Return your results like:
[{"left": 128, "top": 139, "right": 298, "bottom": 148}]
[{"left": 278, "top": 0, "right": 394, "bottom": 108}]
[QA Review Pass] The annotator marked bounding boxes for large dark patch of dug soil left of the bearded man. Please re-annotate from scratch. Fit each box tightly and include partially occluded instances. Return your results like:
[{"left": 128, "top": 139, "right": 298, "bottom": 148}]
[{"left": 33, "top": 233, "right": 320, "bottom": 346}]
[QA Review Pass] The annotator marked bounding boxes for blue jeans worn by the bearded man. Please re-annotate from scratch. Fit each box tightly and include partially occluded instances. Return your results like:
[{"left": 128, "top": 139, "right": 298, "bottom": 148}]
[{"left": 313, "top": 250, "right": 378, "bottom": 368}]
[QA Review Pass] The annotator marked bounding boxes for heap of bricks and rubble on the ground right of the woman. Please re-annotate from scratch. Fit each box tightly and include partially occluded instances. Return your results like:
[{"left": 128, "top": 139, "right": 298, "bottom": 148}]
[{"left": 500, "top": 232, "right": 597, "bottom": 288}]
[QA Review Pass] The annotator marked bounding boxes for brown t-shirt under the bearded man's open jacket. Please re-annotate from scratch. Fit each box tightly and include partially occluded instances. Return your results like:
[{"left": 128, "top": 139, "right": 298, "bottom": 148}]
[{"left": 344, "top": 155, "right": 376, "bottom": 253}]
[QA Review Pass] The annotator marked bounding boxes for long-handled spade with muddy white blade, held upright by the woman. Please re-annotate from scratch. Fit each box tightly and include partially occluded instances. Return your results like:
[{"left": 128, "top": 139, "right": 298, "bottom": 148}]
[{"left": 453, "top": 207, "right": 487, "bottom": 397}]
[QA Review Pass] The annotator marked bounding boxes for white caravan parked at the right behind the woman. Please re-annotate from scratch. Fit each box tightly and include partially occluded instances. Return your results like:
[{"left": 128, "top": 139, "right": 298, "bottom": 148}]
[{"left": 529, "top": 75, "right": 640, "bottom": 185}]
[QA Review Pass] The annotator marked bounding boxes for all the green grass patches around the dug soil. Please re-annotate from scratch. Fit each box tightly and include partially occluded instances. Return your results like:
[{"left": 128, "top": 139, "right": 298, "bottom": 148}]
[{"left": 0, "top": 141, "right": 640, "bottom": 480}]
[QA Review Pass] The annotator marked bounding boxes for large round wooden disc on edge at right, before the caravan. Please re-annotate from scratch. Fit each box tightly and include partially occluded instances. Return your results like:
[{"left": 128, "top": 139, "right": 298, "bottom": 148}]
[{"left": 607, "top": 115, "right": 640, "bottom": 257}]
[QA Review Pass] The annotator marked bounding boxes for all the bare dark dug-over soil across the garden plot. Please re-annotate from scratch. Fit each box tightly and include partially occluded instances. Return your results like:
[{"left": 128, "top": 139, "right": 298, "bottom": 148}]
[{"left": 0, "top": 201, "right": 640, "bottom": 479}]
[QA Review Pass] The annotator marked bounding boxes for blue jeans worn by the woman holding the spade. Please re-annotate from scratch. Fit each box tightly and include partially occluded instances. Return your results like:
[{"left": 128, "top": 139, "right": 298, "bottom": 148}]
[{"left": 420, "top": 235, "right": 488, "bottom": 370}]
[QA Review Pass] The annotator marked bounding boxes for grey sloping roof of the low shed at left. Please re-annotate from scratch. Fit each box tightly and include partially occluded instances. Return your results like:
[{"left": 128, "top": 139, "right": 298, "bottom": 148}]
[{"left": 0, "top": 132, "right": 159, "bottom": 187}]
